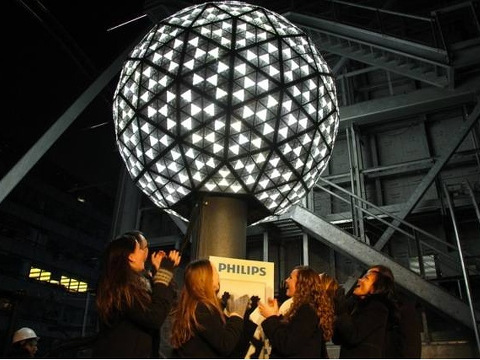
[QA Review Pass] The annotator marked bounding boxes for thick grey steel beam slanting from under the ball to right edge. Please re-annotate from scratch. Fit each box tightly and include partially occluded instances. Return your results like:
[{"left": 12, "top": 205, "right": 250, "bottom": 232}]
[{"left": 281, "top": 206, "right": 478, "bottom": 328}]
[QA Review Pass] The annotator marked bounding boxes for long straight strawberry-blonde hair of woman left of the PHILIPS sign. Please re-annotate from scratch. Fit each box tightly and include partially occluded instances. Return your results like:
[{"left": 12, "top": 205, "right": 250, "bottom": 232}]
[{"left": 170, "top": 259, "right": 225, "bottom": 348}]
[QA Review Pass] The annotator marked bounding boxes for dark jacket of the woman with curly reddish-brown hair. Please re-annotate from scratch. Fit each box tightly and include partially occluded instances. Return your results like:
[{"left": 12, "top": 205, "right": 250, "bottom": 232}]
[{"left": 262, "top": 304, "right": 325, "bottom": 359}]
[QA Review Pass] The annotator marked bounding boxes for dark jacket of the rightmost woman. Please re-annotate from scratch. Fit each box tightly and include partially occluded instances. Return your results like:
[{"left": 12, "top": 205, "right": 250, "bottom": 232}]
[{"left": 332, "top": 295, "right": 389, "bottom": 359}]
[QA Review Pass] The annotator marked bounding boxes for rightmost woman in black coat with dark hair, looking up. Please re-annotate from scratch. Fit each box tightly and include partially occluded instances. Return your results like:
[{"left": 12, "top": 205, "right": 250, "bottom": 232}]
[{"left": 333, "top": 265, "right": 398, "bottom": 359}]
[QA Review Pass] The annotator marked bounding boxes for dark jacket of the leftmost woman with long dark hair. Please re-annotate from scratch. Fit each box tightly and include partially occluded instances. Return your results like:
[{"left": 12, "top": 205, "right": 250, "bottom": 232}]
[{"left": 92, "top": 283, "right": 174, "bottom": 358}]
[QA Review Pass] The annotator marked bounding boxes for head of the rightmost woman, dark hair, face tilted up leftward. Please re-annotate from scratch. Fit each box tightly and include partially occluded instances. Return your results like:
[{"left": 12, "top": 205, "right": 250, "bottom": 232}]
[{"left": 353, "top": 265, "right": 395, "bottom": 298}]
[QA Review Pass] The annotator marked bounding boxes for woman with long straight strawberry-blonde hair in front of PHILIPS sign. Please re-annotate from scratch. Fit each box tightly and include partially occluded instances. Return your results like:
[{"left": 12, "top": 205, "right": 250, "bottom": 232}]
[{"left": 171, "top": 259, "right": 248, "bottom": 358}]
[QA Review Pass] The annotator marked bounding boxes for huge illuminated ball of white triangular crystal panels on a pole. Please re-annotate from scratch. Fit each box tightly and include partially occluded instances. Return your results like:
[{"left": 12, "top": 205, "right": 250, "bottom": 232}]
[{"left": 113, "top": 2, "right": 339, "bottom": 220}]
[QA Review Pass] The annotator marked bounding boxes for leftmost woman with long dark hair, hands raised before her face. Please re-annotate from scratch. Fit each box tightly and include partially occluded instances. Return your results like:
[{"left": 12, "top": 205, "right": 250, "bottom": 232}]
[{"left": 93, "top": 232, "right": 180, "bottom": 358}]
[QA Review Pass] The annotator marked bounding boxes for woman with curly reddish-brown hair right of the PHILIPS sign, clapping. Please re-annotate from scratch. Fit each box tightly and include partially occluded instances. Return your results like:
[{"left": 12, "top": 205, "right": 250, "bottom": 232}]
[{"left": 259, "top": 266, "right": 334, "bottom": 358}]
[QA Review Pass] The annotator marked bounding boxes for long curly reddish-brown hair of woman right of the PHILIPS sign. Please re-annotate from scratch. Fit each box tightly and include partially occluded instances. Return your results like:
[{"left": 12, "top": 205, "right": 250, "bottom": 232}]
[{"left": 284, "top": 266, "right": 334, "bottom": 341}]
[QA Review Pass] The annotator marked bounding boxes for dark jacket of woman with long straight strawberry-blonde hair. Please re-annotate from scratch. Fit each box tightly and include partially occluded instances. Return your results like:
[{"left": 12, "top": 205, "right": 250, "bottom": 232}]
[{"left": 175, "top": 303, "right": 243, "bottom": 358}]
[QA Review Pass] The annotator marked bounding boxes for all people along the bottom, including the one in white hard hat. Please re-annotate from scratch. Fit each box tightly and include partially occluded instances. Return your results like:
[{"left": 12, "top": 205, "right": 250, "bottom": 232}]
[{"left": 6, "top": 231, "right": 421, "bottom": 358}]
